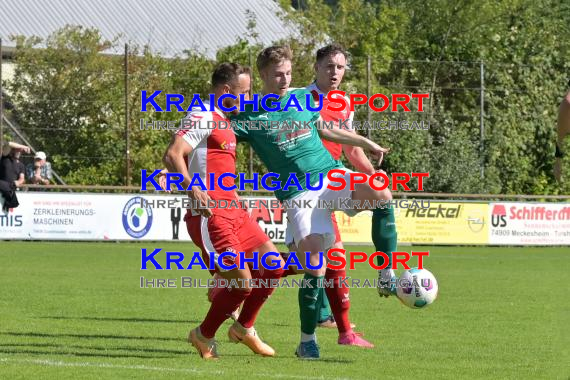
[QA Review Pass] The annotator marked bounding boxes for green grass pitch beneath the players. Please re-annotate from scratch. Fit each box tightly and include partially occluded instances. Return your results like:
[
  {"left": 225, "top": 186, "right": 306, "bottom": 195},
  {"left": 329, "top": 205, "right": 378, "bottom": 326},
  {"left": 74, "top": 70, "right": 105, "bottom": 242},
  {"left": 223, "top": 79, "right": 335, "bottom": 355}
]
[{"left": 0, "top": 242, "right": 570, "bottom": 379}]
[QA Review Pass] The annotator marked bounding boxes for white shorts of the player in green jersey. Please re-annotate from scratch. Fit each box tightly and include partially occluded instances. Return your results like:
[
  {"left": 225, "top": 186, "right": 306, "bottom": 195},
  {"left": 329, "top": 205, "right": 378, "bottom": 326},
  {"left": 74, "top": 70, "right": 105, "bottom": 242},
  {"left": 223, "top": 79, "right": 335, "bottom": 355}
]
[{"left": 285, "top": 168, "right": 360, "bottom": 249}]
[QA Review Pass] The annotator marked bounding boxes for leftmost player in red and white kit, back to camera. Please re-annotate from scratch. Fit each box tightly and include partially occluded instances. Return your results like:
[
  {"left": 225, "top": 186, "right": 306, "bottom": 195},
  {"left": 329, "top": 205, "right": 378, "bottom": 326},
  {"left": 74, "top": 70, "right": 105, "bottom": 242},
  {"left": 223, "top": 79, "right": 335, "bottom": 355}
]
[{"left": 164, "top": 63, "right": 283, "bottom": 359}]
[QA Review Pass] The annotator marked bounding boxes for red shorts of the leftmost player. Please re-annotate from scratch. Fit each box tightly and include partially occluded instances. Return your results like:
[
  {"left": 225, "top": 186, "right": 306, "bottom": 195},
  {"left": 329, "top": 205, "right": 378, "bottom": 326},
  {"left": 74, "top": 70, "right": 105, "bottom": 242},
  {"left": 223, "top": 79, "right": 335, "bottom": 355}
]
[{"left": 184, "top": 209, "right": 269, "bottom": 274}]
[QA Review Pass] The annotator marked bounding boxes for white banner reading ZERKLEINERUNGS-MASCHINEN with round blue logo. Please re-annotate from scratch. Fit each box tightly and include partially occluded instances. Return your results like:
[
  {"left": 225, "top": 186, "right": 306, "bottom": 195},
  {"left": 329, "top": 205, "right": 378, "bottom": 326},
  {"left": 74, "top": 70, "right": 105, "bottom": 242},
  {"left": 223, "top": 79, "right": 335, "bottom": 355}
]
[{"left": 0, "top": 192, "right": 190, "bottom": 241}]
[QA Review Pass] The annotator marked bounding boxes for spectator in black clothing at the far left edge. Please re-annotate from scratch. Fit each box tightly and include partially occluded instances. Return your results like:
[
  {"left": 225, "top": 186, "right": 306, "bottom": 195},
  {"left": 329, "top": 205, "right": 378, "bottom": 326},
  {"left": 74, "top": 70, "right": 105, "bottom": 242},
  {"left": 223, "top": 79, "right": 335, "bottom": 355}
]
[{"left": 0, "top": 142, "right": 30, "bottom": 212}]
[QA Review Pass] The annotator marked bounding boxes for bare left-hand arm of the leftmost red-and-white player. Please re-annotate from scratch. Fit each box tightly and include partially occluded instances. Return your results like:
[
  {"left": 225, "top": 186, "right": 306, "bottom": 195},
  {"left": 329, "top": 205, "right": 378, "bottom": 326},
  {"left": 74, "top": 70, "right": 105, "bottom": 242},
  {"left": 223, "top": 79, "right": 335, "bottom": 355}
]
[{"left": 162, "top": 128, "right": 212, "bottom": 217}]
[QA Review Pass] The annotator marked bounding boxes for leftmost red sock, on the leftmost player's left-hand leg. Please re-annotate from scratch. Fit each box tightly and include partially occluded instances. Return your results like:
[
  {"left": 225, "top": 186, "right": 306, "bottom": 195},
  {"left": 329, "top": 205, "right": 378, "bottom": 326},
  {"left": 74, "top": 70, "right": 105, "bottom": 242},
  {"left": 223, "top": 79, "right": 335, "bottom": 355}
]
[{"left": 200, "top": 287, "right": 250, "bottom": 339}]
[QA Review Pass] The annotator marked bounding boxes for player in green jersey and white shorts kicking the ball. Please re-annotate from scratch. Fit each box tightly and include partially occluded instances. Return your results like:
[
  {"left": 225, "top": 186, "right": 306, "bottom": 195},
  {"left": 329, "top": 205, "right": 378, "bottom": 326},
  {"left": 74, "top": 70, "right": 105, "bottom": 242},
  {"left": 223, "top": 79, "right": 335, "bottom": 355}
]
[{"left": 233, "top": 46, "right": 392, "bottom": 359}]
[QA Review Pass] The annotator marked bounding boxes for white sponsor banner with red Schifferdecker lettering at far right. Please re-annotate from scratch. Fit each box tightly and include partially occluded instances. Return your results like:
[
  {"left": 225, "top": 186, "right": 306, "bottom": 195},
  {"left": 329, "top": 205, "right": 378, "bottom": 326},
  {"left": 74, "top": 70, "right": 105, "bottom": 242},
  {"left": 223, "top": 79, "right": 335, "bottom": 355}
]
[{"left": 489, "top": 202, "right": 570, "bottom": 245}]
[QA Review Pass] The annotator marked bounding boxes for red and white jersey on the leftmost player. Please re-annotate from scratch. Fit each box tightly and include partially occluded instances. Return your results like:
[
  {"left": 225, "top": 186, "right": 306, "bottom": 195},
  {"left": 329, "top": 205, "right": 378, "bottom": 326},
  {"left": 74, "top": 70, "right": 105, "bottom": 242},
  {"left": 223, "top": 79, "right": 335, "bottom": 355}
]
[{"left": 176, "top": 103, "right": 237, "bottom": 200}]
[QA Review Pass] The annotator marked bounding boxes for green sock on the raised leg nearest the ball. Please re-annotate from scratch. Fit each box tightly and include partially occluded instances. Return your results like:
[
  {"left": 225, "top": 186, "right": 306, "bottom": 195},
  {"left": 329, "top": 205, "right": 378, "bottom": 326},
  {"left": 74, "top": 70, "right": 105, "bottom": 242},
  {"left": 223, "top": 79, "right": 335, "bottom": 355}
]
[{"left": 372, "top": 207, "right": 398, "bottom": 269}]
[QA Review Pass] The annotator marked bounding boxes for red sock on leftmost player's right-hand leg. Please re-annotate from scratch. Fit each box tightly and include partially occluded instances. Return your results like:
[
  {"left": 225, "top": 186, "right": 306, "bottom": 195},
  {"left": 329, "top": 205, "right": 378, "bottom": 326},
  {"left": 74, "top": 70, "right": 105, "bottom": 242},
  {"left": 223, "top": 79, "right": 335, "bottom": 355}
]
[{"left": 238, "top": 268, "right": 283, "bottom": 328}]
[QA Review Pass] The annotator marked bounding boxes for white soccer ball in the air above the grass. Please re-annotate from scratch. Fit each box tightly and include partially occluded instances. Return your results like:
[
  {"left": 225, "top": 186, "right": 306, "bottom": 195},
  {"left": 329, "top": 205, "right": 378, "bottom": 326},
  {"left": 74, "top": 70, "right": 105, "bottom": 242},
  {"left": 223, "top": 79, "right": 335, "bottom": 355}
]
[{"left": 396, "top": 268, "right": 438, "bottom": 309}]
